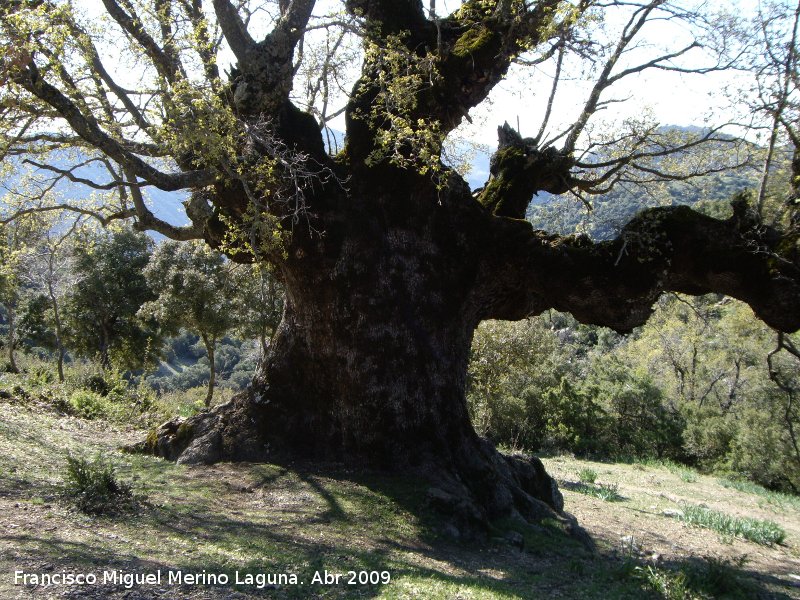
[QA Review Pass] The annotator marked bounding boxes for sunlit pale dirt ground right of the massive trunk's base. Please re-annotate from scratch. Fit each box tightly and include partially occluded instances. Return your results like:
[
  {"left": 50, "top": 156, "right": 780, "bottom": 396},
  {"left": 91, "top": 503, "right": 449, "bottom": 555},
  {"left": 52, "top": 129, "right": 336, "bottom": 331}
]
[{"left": 544, "top": 457, "right": 800, "bottom": 597}]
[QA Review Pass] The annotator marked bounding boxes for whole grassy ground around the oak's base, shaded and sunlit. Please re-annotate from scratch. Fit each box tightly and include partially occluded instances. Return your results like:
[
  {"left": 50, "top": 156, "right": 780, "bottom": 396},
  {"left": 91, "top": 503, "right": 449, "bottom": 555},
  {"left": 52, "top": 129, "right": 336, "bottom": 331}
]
[{"left": 0, "top": 398, "right": 800, "bottom": 599}]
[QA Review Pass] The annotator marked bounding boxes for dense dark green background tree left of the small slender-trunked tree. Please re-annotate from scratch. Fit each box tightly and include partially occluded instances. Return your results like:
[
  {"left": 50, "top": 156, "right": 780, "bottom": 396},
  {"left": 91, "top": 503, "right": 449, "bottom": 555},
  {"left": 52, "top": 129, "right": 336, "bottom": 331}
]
[{"left": 64, "top": 228, "right": 158, "bottom": 369}]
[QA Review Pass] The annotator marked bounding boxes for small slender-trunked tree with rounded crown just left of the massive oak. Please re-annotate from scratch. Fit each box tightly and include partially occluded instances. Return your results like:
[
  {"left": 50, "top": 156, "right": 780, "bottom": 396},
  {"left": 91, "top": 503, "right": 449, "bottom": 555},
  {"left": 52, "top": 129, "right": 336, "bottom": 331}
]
[{"left": 141, "top": 242, "right": 236, "bottom": 406}]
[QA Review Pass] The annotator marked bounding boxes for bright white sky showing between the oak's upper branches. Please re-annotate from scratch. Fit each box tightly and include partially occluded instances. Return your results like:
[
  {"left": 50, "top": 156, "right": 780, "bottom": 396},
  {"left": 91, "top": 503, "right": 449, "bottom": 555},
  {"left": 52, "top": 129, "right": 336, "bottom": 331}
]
[{"left": 29, "top": 0, "right": 789, "bottom": 223}]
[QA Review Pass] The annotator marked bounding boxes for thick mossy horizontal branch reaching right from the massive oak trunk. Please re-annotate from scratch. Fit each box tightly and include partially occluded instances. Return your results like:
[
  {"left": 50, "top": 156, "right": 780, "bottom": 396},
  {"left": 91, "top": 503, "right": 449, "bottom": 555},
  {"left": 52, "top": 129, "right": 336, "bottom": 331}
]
[{"left": 476, "top": 202, "right": 800, "bottom": 332}]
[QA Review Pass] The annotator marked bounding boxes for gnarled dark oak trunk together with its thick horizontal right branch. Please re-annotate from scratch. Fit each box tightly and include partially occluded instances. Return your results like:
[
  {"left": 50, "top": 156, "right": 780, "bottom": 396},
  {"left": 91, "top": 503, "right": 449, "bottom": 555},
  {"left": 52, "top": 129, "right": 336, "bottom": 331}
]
[{"left": 144, "top": 151, "right": 800, "bottom": 531}]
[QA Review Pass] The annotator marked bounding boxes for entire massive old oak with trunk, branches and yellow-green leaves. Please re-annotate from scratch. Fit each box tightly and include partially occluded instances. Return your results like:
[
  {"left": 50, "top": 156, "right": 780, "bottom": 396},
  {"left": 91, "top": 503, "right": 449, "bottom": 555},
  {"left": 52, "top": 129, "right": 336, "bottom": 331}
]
[{"left": 0, "top": 0, "right": 800, "bottom": 527}]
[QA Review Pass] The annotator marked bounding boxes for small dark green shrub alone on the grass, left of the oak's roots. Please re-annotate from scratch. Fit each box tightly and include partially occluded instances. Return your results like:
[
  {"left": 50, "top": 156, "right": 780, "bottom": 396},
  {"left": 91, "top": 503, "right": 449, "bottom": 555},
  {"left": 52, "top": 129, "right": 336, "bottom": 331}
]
[{"left": 64, "top": 456, "right": 135, "bottom": 515}]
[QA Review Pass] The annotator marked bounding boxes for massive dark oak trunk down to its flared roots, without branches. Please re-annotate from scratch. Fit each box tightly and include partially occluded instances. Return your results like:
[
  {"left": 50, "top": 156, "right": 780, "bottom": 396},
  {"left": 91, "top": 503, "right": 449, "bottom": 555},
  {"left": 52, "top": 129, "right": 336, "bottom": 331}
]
[{"left": 145, "top": 173, "right": 562, "bottom": 532}]
